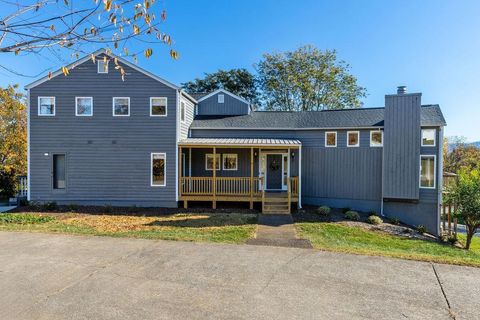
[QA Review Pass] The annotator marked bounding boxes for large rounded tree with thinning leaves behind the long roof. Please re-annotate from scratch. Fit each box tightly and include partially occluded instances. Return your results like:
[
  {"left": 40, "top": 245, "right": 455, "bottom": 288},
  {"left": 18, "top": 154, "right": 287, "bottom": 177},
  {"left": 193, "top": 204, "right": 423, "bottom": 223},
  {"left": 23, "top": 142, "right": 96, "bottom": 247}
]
[{"left": 255, "top": 46, "right": 366, "bottom": 111}]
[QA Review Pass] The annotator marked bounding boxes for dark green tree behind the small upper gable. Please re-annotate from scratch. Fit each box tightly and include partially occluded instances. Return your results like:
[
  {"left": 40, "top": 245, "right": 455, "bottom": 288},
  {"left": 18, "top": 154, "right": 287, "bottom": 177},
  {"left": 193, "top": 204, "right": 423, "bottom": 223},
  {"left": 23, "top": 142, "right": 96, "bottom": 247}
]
[{"left": 182, "top": 68, "right": 258, "bottom": 103}]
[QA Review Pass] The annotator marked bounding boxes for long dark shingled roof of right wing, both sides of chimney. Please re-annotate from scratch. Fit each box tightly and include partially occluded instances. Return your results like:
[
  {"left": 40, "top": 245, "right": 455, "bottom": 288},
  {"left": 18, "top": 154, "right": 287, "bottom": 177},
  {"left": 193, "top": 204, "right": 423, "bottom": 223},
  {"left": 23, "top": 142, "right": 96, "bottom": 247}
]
[{"left": 191, "top": 105, "right": 446, "bottom": 130}]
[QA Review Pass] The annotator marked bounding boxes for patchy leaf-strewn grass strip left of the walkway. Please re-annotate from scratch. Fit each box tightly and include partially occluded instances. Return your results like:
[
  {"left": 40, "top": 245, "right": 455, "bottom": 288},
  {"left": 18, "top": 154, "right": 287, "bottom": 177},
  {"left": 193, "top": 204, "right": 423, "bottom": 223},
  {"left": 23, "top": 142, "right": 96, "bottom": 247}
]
[{"left": 0, "top": 213, "right": 257, "bottom": 243}]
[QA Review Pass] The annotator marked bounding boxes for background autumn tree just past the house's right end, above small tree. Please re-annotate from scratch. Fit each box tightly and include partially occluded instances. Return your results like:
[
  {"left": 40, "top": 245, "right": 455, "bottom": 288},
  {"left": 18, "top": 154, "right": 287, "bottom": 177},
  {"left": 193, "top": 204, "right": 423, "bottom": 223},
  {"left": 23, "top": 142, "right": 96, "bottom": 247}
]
[{"left": 444, "top": 137, "right": 480, "bottom": 173}]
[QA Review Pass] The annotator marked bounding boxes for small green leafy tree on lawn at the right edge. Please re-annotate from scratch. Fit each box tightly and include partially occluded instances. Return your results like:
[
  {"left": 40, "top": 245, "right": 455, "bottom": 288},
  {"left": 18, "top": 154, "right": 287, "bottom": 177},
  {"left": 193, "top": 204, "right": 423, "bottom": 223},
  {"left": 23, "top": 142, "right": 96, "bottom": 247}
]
[{"left": 449, "top": 169, "right": 480, "bottom": 250}]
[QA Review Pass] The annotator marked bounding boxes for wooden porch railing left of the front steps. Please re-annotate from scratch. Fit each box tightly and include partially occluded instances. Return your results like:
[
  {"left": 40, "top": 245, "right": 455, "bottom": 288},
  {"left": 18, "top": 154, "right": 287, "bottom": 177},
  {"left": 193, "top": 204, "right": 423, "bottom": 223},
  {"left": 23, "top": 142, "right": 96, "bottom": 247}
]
[{"left": 180, "top": 177, "right": 261, "bottom": 197}]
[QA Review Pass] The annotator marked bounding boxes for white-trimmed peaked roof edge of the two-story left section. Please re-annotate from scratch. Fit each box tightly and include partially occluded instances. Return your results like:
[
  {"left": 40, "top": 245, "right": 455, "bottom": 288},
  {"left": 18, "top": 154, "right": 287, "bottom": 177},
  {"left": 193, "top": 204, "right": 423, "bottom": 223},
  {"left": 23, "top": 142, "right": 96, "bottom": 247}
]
[{"left": 25, "top": 48, "right": 180, "bottom": 90}]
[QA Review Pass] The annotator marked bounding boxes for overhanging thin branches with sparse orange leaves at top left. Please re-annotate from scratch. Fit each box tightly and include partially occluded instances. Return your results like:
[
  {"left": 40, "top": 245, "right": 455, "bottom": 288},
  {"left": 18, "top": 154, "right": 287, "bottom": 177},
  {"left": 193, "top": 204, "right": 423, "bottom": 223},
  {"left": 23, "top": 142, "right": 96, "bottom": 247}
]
[{"left": 0, "top": 0, "right": 178, "bottom": 76}]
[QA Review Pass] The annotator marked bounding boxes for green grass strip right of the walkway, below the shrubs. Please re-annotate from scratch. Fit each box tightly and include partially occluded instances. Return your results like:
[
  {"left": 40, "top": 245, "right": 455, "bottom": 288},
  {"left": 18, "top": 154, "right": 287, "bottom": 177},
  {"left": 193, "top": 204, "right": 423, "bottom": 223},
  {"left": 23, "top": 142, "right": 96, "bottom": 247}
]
[{"left": 296, "top": 222, "right": 480, "bottom": 267}]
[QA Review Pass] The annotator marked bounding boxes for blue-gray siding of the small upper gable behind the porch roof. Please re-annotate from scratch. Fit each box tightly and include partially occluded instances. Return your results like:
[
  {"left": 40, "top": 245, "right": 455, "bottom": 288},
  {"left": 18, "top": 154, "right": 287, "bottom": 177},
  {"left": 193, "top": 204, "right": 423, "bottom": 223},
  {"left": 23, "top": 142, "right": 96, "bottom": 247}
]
[{"left": 197, "top": 92, "right": 249, "bottom": 116}]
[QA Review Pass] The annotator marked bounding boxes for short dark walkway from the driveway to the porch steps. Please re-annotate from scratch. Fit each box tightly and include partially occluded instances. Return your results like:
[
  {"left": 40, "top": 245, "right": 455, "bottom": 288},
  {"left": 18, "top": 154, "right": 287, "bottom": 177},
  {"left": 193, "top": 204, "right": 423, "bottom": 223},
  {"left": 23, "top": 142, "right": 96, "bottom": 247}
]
[{"left": 247, "top": 214, "right": 312, "bottom": 249}]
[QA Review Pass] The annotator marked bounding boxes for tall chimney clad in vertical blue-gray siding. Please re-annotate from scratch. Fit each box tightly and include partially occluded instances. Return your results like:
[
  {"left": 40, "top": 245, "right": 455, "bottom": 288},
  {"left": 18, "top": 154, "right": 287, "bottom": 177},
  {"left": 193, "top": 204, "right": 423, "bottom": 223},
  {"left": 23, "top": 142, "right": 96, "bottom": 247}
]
[{"left": 383, "top": 94, "right": 421, "bottom": 199}]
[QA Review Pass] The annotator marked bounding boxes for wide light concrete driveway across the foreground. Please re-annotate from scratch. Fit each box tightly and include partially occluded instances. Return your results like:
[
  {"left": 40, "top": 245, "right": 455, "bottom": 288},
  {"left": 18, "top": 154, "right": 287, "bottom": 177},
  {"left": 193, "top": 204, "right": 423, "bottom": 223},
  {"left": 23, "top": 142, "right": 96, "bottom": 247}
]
[{"left": 0, "top": 232, "right": 480, "bottom": 319}]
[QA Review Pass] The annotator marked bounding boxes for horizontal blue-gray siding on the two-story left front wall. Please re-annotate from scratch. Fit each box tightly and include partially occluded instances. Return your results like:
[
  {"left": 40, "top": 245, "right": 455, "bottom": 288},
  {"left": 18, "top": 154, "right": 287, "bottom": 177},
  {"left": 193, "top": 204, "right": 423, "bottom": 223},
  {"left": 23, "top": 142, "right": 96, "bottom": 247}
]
[{"left": 30, "top": 53, "right": 177, "bottom": 206}]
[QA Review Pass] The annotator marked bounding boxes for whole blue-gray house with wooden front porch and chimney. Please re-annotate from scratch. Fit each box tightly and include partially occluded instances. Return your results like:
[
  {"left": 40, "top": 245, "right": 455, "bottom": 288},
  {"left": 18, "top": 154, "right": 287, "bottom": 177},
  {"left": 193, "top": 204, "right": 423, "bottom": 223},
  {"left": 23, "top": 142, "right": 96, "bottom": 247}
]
[{"left": 26, "top": 50, "right": 446, "bottom": 234}]
